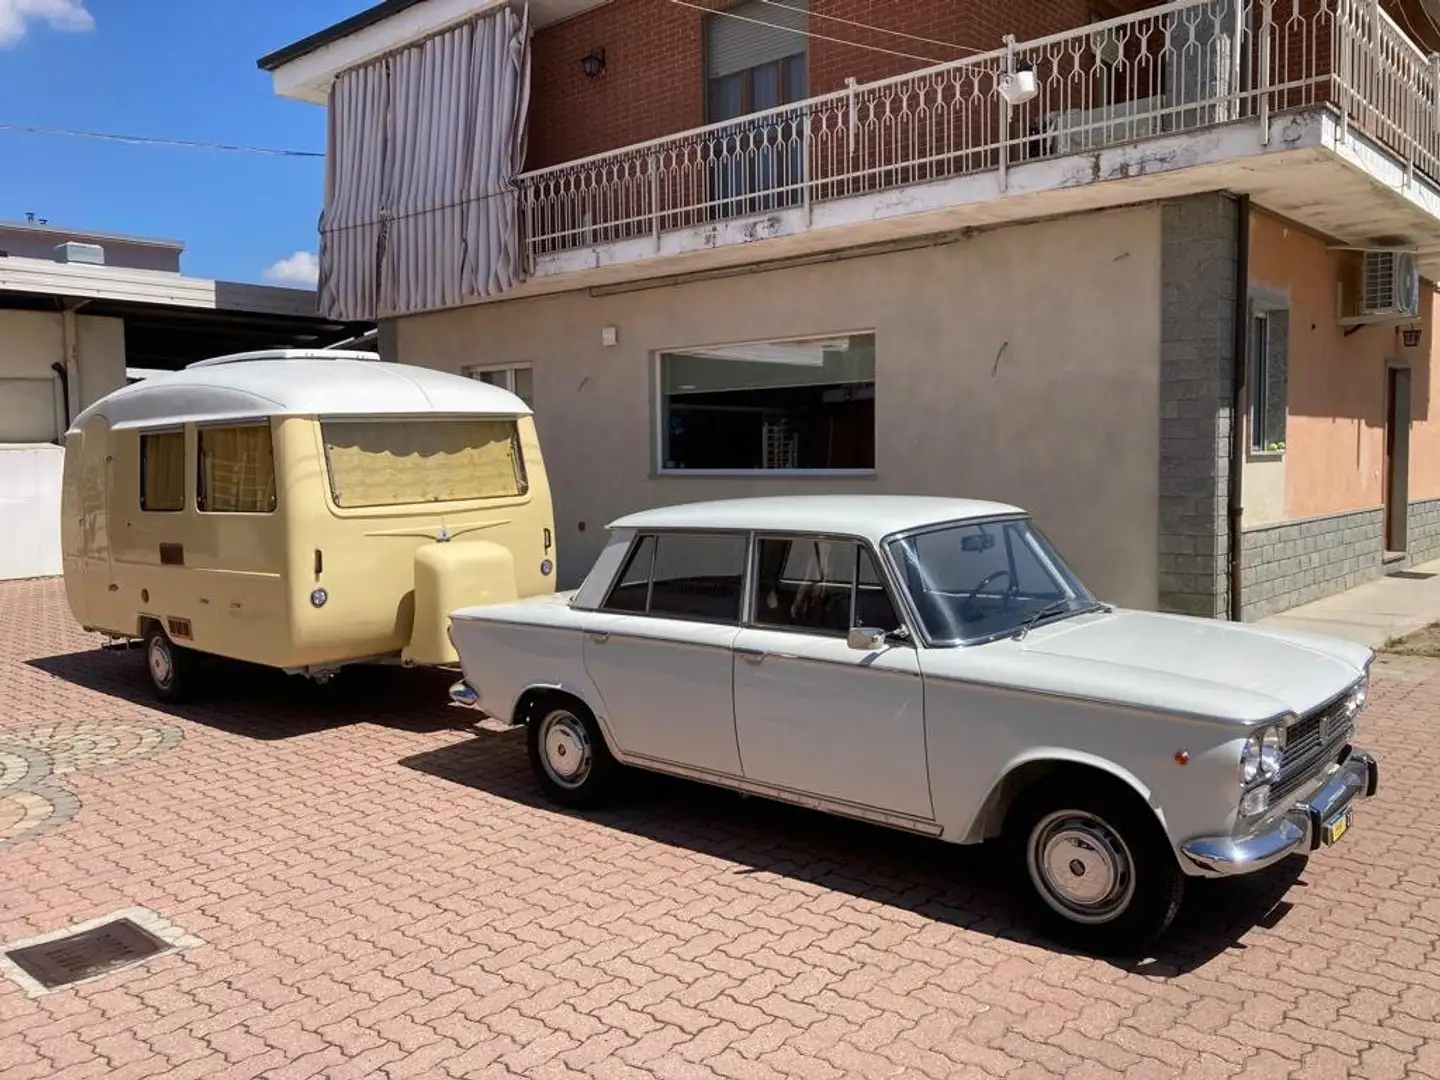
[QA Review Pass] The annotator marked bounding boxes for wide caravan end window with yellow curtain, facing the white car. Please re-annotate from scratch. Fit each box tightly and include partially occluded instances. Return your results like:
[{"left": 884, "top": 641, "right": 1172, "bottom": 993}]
[{"left": 320, "top": 419, "right": 528, "bottom": 507}]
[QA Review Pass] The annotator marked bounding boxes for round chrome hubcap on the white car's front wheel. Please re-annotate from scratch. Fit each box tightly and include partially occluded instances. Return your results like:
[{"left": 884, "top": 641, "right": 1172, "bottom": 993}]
[{"left": 1028, "top": 811, "right": 1135, "bottom": 923}]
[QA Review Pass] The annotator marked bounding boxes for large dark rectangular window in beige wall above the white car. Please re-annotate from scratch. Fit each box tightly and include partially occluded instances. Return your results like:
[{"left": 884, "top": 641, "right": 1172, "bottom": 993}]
[{"left": 658, "top": 333, "right": 876, "bottom": 472}]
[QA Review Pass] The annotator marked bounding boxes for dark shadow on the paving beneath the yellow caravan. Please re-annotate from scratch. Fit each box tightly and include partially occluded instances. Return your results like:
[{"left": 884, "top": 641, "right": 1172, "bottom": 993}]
[{"left": 26, "top": 648, "right": 474, "bottom": 740}]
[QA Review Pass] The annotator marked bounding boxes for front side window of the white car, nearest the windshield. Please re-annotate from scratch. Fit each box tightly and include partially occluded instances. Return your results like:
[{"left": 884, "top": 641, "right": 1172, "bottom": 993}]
[{"left": 753, "top": 537, "right": 900, "bottom": 636}]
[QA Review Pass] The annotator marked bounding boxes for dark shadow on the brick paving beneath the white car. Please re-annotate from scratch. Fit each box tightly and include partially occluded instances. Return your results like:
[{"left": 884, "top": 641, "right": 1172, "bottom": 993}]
[{"left": 400, "top": 730, "right": 1305, "bottom": 978}]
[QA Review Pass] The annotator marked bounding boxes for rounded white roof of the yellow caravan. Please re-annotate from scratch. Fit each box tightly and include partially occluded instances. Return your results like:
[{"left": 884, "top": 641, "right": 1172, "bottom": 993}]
[{"left": 71, "top": 348, "right": 530, "bottom": 431}]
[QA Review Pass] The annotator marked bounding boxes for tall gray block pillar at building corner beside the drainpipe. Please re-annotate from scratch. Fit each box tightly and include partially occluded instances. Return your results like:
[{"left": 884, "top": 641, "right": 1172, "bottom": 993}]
[{"left": 1159, "top": 193, "right": 1238, "bottom": 618}]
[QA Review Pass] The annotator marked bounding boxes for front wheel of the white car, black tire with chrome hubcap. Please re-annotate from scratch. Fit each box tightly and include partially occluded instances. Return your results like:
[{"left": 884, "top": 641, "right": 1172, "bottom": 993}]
[{"left": 1005, "top": 778, "right": 1185, "bottom": 956}]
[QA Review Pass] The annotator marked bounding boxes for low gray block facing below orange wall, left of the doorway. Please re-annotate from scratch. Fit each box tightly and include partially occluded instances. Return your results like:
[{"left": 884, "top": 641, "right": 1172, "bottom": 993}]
[{"left": 1240, "top": 508, "right": 1384, "bottom": 621}]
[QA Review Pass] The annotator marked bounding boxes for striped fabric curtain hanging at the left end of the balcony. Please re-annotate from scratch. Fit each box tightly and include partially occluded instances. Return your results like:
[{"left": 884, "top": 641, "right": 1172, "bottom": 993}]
[{"left": 320, "top": 7, "right": 530, "bottom": 320}]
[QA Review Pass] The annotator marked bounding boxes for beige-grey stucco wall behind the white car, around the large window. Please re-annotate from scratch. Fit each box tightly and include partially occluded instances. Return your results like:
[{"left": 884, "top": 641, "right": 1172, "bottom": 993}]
[{"left": 396, "top": 207, "right": 1161, "bottom": 606}]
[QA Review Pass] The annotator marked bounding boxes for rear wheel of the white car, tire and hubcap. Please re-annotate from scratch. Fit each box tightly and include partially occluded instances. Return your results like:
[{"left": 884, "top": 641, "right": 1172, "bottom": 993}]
[{"left": 526, "top": 696, "right": 621, "bottom": 809}]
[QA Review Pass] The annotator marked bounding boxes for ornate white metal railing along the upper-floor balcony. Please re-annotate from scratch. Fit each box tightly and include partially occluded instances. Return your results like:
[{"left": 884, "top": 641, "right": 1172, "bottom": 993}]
[{"left": 517, "top": 0, "right": 1440, "bottom": 259}]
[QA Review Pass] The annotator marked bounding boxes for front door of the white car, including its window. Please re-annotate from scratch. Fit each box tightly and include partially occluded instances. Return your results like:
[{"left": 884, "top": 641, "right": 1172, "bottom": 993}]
[{"left": 734, "top": 537, "right": 933, "bottom": 819}]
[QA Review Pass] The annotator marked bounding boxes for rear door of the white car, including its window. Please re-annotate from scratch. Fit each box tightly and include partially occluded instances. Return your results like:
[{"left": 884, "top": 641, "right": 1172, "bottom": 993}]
[{"left": 583, "top": 533, "right": 747, "bottom": 776}]
